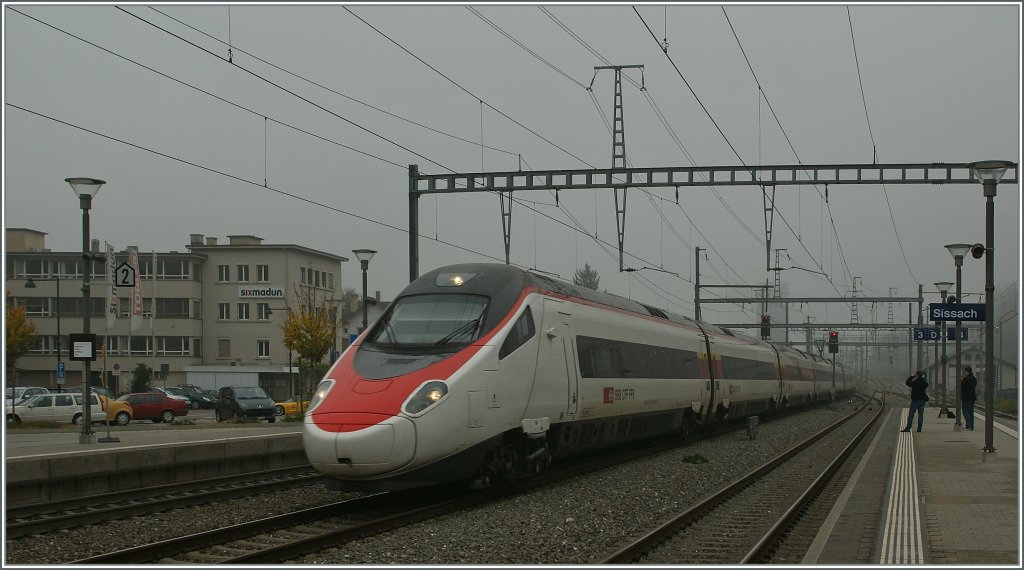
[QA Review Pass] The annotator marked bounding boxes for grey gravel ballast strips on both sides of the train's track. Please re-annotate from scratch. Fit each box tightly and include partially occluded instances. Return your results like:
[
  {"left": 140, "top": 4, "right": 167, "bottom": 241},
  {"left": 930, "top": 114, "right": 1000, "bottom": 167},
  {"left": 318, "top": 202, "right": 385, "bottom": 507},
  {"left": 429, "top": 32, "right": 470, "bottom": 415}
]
[{"left": 4, "top": 408, "right": 838, "bottom": 565}]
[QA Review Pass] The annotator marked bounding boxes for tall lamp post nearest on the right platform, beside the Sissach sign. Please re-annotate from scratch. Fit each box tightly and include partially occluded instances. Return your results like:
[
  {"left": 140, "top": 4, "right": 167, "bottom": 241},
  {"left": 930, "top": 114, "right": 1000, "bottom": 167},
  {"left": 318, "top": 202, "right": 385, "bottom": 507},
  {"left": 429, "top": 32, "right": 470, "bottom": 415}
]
[{"left": 968, "top": 161, "right": 1013, "bottom": 463}]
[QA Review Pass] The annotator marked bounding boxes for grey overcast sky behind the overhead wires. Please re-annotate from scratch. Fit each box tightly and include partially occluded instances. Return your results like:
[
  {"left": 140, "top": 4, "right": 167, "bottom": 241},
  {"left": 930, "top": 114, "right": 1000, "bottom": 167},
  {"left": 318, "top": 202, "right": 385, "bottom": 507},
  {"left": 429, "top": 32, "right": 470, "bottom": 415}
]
[{"left": 3, "top": 2, "right": 1021, "bottom": 333}]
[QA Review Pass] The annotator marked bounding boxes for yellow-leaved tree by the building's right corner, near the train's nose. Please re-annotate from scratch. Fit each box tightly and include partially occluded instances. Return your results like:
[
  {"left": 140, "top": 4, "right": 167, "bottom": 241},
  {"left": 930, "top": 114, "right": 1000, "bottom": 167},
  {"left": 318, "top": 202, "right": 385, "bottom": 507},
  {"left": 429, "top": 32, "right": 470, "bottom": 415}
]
[{"left": 281, "top": 286, "right": 338, "bottom": 394}]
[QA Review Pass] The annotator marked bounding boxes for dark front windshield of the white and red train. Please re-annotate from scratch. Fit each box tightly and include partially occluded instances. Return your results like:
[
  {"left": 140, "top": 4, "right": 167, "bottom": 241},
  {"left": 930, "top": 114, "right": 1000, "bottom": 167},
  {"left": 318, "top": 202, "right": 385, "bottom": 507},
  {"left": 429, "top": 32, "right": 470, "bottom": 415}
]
[{"left": 368, "top": 294, "right": 487, "bottom": 346}]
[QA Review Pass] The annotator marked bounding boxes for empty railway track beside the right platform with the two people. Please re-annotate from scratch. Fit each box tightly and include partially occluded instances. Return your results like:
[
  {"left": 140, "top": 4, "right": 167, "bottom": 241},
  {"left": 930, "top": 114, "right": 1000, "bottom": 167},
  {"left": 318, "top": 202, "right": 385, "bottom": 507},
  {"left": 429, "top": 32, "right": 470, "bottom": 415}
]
[{"left": 597, "top": 392, "right": 883, "bottom": 564}]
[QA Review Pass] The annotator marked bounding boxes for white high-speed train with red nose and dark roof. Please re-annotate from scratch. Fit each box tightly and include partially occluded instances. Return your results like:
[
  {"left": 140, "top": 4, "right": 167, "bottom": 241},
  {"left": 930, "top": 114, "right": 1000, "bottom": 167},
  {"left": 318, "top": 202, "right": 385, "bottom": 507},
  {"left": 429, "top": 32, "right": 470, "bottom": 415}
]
[{"left": 302, "top": 264, "right": 852, "bottom": 490}]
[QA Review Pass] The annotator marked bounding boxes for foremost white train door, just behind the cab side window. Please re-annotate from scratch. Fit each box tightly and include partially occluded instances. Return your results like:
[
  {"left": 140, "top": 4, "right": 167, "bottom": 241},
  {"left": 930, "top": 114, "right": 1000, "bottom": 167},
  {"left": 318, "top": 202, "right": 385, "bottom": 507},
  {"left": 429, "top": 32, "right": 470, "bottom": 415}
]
[{"left": 529, "top": 298, "right": 580, "bottom": 424}]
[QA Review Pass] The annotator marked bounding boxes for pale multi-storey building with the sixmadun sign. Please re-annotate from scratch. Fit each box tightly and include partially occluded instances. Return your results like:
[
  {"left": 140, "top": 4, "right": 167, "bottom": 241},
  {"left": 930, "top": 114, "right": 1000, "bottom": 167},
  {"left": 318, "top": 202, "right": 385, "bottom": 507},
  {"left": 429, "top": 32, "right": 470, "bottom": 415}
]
[{"left": 4, "top": 228, "right": 348, "bottom": 399}]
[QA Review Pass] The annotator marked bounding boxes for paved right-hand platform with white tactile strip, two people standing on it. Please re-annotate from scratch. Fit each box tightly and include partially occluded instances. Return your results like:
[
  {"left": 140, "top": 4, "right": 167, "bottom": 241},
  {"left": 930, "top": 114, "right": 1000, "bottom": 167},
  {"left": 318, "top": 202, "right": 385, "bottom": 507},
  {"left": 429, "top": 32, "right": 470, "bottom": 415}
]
[{"left": 803, "top": 404, "right": 1021, "bottom": 568}]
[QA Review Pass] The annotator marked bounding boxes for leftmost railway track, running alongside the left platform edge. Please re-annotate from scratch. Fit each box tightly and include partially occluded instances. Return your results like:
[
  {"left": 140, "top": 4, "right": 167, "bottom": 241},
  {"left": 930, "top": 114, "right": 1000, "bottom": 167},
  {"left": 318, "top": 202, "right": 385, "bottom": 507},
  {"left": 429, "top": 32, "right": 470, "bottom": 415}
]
[{"left": 4, "top": 467, "right": 323, "bottom": 539}]
